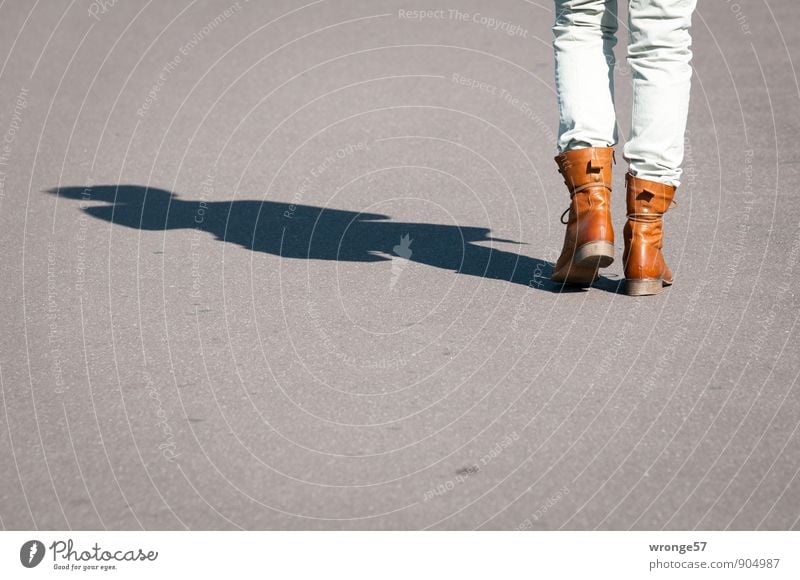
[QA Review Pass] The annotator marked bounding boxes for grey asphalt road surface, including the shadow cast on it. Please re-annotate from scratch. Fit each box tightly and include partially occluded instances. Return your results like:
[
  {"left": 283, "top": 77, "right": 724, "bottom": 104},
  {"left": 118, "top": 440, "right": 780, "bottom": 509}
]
[{"left": 0, "top": 0, "right": 800, "bottom": 530}]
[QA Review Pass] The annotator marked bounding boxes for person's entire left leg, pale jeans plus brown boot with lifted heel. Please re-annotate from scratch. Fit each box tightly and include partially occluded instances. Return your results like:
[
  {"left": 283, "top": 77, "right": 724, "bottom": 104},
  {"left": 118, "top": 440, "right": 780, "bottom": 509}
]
[{"left": 550, "top": 0, "right": 617, "bottom": 286}]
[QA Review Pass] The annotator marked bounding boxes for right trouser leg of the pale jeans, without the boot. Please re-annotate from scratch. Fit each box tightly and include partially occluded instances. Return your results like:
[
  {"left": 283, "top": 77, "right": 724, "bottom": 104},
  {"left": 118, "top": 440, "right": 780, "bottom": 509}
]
[{"left": 624, "top": 0, "right": 696, "bottom": 187}]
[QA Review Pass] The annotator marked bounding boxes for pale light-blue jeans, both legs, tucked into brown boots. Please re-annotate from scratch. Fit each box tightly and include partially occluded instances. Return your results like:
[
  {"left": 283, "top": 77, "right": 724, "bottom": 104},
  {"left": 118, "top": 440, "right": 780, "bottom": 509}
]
[{"left": 553, "top": 0, "right": 697, "bottom": 186}]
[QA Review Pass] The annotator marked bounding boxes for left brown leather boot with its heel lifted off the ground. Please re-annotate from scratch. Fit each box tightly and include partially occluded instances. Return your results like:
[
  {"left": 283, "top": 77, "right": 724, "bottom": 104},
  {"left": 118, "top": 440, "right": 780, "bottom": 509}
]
[{"left": 550, "top": 147, "right": 614, "bottom": 286}]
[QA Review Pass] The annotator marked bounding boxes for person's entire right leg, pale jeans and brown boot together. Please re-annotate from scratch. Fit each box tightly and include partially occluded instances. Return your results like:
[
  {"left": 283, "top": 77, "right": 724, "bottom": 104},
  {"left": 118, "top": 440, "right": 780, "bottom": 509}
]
[{"left": 623, "top": 0, "right": 696, "bottom": 296}]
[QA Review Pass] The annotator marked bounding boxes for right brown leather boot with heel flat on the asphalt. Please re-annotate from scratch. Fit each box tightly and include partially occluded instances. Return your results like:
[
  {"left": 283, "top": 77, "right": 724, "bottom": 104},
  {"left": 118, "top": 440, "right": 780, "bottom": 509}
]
[{"left": 622, "top": 173, "right": 675, "bottom": 296}]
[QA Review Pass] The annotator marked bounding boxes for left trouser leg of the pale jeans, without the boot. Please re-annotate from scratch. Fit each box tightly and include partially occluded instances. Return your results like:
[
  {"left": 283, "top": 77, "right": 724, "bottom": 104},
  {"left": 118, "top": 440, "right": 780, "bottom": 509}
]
[{"left": 553, "top": 0, "right": 617, "bottom": 153}]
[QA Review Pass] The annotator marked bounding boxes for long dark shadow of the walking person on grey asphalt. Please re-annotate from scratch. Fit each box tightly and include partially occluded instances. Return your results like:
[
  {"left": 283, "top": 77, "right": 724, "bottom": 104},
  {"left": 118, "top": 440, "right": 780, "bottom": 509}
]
[{"left": 47, "top": 185, "right": 614, "bottom": 292}]
